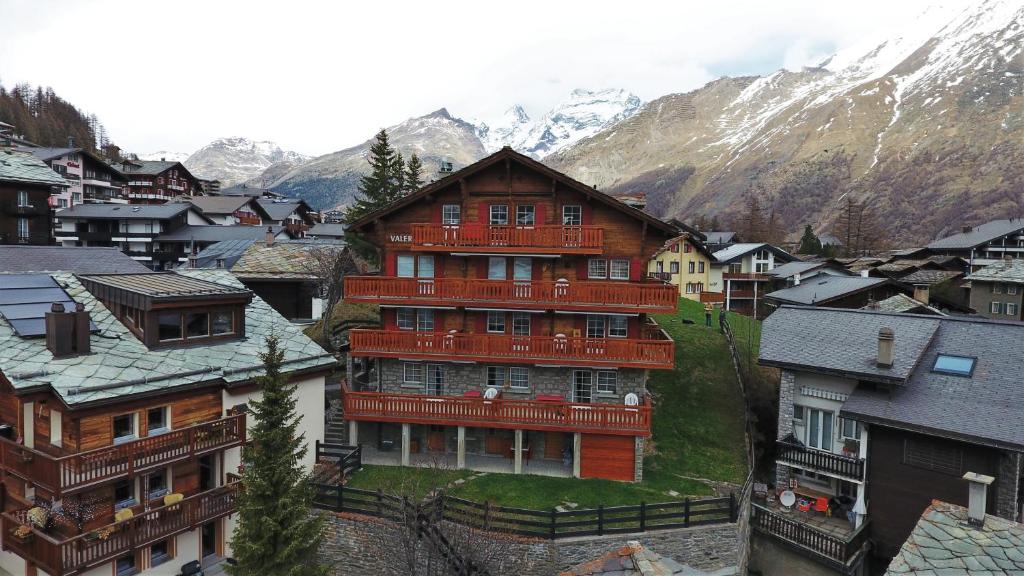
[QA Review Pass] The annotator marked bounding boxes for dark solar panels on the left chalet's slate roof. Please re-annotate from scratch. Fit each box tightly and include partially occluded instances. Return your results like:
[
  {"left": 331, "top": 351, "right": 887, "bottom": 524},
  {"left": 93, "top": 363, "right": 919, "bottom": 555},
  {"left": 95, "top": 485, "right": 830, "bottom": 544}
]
[{"left": 0, "top": 274, "right": 96, "bottom": 338}]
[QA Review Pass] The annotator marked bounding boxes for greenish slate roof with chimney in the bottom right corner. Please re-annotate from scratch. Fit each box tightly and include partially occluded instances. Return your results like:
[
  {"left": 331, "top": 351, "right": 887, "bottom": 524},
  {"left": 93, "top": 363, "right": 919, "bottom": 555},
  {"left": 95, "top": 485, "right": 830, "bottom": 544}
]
[{"left": 886, "top": 500, "right": 1024, "bottom": 576}]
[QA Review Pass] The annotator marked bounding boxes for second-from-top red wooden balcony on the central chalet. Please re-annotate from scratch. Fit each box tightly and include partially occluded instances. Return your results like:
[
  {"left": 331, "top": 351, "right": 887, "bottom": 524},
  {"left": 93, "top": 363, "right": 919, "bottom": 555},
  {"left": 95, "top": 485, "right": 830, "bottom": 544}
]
[{"left": 344, "top": 276, "right": 679, "bottom": 314}]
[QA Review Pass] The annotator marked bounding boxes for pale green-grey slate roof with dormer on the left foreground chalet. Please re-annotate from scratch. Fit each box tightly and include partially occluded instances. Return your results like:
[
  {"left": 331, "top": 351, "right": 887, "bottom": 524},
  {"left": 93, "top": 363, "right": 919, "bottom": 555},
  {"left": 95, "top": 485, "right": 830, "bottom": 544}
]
[{"left": 0, "top": 270, "right": 335, "bottom": 405}]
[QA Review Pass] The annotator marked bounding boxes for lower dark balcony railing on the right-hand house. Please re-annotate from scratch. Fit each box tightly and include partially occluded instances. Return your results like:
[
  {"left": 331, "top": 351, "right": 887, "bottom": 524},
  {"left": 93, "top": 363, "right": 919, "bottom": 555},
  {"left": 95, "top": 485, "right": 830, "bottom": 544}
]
[{"left": 751, "top": 504, "right": 867, "bottom": 574}]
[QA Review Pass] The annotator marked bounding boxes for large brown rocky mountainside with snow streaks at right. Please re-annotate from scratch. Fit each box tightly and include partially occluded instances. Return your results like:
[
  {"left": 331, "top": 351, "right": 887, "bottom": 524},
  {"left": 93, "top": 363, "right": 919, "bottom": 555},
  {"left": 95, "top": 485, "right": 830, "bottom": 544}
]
[{"left": 545, "top": 0, "right": 1024, "bottom": 244}]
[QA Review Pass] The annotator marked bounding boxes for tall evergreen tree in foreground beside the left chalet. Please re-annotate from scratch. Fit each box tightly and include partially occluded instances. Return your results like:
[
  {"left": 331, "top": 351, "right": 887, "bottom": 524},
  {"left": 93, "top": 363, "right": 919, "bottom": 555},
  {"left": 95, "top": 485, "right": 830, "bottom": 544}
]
[{"left": 227, "top": 336, "right": 327, "bottom": 576}]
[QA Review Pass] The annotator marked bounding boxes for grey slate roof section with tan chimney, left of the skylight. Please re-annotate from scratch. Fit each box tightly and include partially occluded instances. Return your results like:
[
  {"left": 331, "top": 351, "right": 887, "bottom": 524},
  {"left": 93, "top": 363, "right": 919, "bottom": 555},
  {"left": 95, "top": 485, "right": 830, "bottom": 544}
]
[{"left": 759, "top": 305, "right": 937, "bottom": 383}]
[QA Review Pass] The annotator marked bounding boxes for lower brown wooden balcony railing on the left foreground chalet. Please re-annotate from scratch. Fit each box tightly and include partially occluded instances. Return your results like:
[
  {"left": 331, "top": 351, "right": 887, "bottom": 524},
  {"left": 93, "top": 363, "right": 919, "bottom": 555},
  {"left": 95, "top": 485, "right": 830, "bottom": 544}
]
[{"left": 3, "top": 483, "right": 239, "bottom": 576}]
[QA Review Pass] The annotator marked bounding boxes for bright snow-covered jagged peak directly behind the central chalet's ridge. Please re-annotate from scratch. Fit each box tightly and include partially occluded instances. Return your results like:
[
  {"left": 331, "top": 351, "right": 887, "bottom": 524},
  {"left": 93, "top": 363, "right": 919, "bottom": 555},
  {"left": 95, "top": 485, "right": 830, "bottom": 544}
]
[{"left": 477, "top": 88, "right": 643, "bottom": 158}]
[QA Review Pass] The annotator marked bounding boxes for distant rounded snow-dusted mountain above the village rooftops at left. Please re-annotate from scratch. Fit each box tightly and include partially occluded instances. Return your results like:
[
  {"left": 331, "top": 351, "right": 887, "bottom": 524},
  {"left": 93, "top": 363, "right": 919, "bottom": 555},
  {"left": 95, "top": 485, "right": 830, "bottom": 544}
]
[{"left": 184, "top": 137, "right": 309, "bottom": 187}]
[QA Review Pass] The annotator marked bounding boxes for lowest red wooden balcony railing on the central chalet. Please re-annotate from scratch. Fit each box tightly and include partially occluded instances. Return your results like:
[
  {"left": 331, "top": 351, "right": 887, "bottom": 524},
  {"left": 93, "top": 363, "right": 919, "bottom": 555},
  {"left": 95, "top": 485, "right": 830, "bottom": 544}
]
[{"left": 342, "top": 383, "right": 650, "bottom": 436}]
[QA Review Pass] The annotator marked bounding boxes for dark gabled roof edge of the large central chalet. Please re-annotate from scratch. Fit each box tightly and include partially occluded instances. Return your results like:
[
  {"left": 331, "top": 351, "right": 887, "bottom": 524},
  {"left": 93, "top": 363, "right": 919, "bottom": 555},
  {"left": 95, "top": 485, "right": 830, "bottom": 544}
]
[{"left": 349, "top": 147, "right": 678, "bottom": 236}]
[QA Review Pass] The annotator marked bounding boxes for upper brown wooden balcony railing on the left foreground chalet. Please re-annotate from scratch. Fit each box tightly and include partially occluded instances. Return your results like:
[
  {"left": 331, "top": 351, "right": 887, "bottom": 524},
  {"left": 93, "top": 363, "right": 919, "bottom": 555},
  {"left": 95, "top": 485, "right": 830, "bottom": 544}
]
[{"left": 0, "top": 414, "right": 246, "bottom": 498}]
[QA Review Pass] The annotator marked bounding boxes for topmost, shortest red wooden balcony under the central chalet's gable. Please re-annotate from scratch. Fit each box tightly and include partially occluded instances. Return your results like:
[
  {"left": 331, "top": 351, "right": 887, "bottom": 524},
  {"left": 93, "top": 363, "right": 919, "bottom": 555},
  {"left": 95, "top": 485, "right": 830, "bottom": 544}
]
[{"left": 413, "top": 223, "right": 604, "bottom": 254}]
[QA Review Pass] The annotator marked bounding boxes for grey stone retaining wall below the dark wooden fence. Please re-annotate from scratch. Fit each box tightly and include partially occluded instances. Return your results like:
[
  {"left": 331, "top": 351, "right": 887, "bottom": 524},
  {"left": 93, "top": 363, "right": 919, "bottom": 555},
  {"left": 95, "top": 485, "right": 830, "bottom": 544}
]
[{"left": 319, "top": 508, "right": 741, "bottom": 576}]
